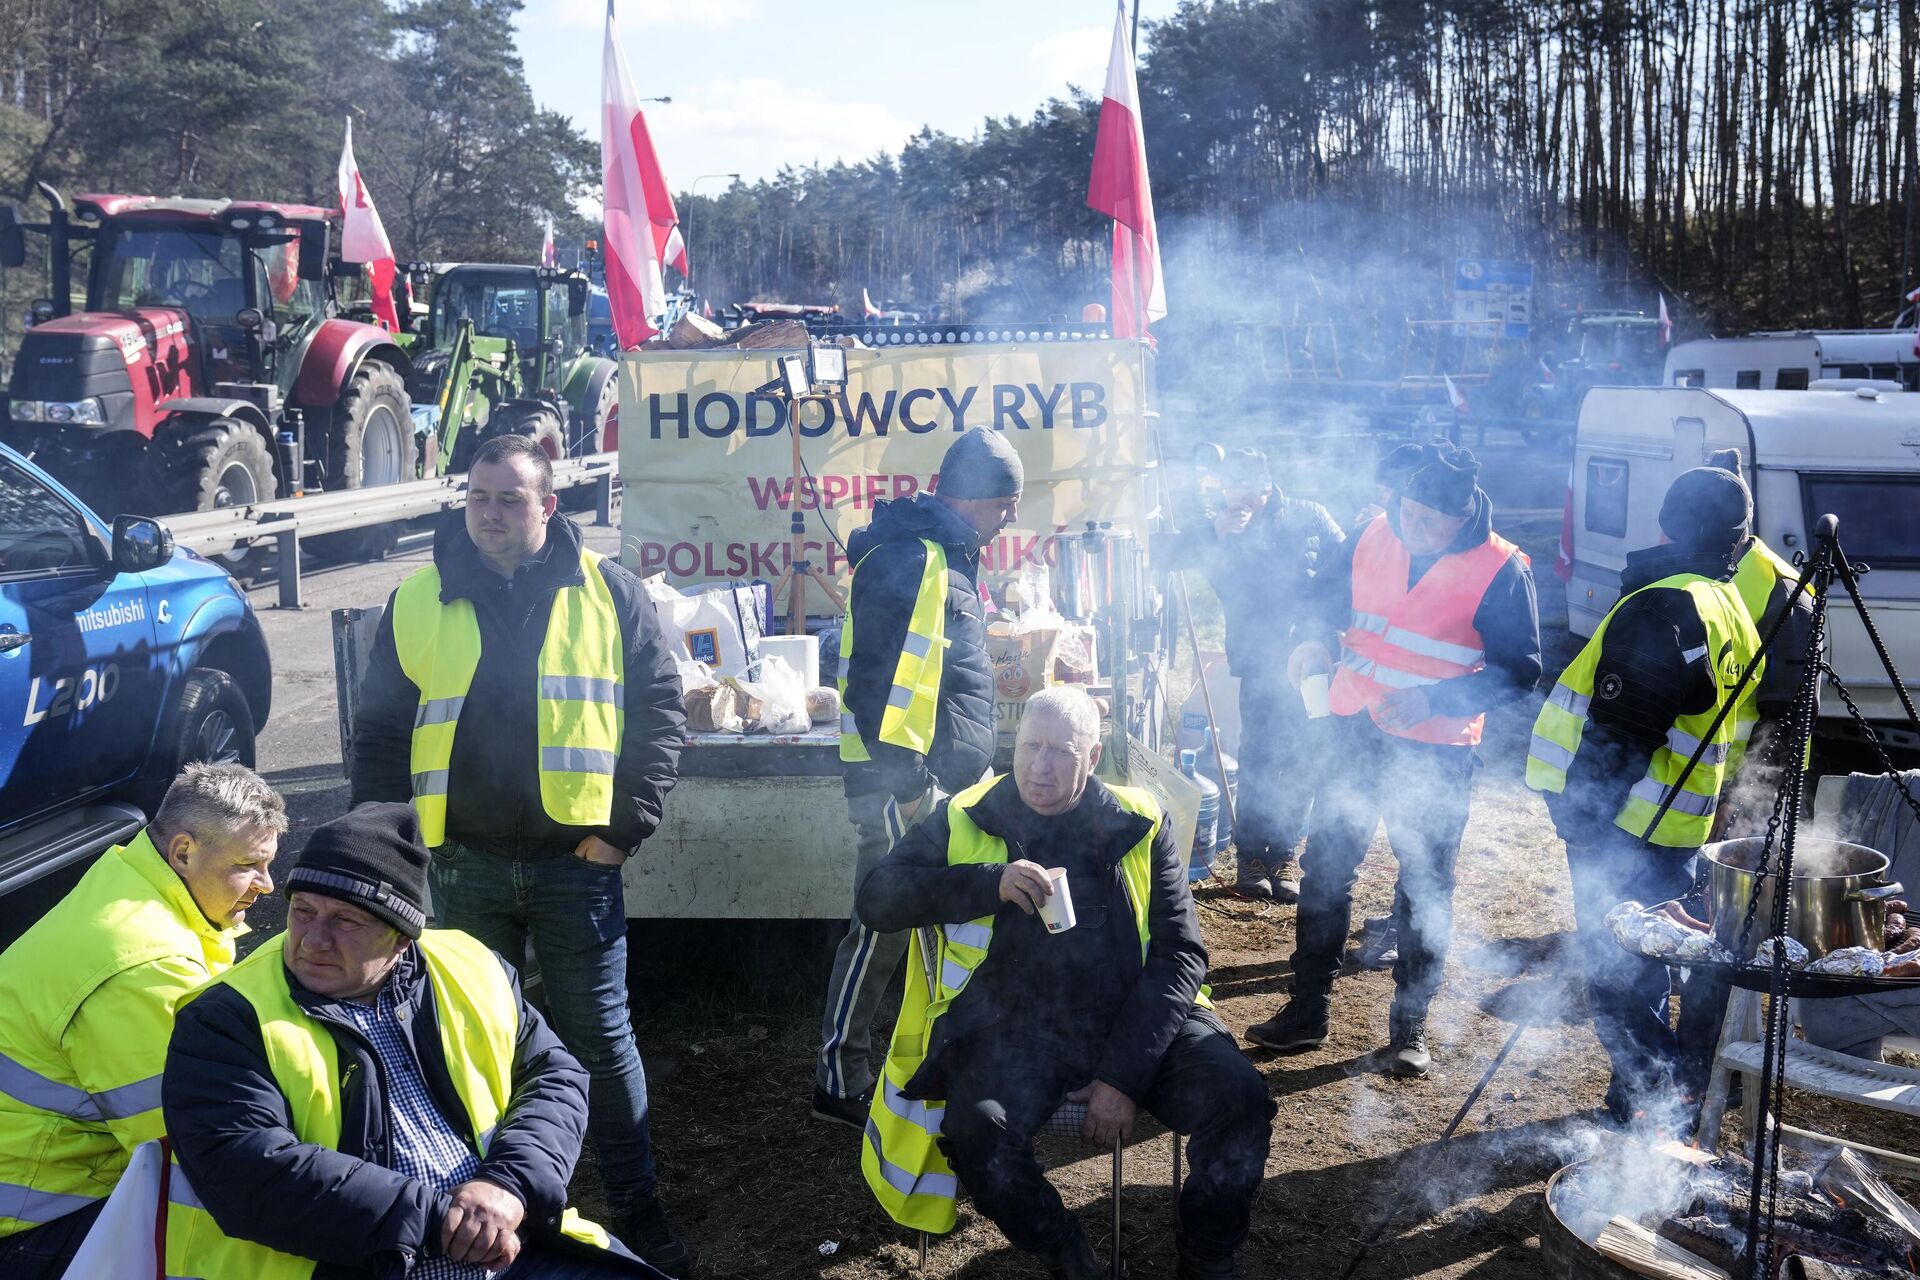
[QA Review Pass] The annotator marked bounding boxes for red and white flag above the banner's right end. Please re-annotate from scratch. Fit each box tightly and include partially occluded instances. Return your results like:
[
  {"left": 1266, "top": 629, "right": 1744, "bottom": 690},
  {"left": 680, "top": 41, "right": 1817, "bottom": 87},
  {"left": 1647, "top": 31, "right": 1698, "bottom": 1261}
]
[{"left": 1087, "top": 0, "right": 1167, "bottom": 338}]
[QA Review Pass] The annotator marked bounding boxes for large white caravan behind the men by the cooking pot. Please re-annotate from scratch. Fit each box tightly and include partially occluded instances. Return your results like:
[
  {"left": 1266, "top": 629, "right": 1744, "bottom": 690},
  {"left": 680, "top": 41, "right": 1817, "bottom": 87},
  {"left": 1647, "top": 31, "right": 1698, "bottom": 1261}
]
[{"left": 1567, "top": 388, "right": 1920, "bottom": 748}]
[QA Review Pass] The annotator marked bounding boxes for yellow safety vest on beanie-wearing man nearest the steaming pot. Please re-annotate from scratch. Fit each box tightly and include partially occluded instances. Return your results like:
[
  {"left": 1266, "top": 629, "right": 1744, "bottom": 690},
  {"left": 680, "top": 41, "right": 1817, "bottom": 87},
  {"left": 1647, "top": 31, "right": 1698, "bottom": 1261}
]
[{"left": 1526, "top": 574, "right": 1764, "bottom": 848}]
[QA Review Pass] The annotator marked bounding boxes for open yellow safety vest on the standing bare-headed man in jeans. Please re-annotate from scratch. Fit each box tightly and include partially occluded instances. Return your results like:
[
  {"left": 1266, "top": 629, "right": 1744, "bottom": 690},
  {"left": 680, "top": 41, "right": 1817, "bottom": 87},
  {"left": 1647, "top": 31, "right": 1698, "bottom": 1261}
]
[{"left": 394, "top": 549, "right": 626, "bottom": 844}]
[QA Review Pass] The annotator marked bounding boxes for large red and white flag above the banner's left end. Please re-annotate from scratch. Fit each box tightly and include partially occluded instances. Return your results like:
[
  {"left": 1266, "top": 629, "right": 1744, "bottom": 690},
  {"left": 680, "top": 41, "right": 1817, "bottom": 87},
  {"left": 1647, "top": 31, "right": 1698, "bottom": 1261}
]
[{"left": 601, "top": 0, "right": 687, "bottom": 351}]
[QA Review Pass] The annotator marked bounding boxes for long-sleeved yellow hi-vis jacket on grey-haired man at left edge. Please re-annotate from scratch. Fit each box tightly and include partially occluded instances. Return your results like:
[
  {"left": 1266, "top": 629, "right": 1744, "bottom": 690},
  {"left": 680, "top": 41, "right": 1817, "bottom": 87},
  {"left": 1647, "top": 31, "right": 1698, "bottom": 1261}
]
[{"left": 0, "top": 831, "right": 242, "bottom": 1238}]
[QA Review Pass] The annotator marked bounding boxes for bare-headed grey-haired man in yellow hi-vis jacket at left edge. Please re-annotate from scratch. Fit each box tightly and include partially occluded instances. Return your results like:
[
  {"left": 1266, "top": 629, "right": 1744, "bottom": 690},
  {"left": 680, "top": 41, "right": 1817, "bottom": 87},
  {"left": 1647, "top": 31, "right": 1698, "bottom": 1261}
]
[{"left": 0, "top": 764, "right": 286, "bottom": 1280}]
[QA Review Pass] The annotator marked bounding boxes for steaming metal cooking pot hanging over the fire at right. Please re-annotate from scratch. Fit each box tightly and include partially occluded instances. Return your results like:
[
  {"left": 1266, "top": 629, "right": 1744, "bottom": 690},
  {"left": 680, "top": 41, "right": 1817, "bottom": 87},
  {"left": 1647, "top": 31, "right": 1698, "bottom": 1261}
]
[{"left": 1699, "top": 835, "right": 1905, "bottom": 960}]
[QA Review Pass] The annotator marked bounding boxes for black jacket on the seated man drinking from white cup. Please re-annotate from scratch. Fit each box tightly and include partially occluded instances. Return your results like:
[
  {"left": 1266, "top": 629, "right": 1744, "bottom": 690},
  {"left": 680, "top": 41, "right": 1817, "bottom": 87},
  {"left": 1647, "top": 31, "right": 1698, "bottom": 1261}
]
[{"left": 854, "top": 777, "right": 1206, "bottom": 1102}]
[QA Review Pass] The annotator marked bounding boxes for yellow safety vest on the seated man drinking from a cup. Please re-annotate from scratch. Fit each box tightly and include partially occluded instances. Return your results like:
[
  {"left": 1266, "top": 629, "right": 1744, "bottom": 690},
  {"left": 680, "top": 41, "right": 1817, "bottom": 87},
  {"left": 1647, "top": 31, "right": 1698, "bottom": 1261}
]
[{"left": 860, "top": 775, "right": 1213, "bottom": 1232}]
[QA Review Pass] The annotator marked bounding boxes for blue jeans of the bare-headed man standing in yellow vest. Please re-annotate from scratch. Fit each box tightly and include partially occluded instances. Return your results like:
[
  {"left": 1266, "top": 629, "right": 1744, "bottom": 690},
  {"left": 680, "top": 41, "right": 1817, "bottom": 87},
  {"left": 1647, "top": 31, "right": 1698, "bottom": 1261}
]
[{"left": 430, "top": 841, "right": 655, "bottom": 1217}]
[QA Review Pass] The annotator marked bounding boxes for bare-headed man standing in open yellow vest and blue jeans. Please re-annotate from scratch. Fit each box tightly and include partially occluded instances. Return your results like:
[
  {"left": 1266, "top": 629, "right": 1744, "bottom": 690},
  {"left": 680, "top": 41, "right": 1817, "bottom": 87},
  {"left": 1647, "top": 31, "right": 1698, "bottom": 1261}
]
[{"left": 351, "top": 436, "right": 687, "bottom": 1274}]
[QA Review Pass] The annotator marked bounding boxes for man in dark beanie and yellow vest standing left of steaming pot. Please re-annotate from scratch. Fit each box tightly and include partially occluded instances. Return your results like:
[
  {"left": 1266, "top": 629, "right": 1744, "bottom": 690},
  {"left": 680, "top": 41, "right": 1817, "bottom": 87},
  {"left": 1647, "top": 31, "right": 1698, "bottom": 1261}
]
[{"left": 1526, "top": 466, "right": 1759, "bottom": 1121}]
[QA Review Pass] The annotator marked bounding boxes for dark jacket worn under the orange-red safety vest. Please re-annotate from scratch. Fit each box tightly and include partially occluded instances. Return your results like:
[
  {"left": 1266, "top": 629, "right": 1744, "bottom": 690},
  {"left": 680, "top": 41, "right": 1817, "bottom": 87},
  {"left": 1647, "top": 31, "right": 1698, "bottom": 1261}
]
[{"left": 1300, "top": 489, "right": 1546, "bottom": 716}]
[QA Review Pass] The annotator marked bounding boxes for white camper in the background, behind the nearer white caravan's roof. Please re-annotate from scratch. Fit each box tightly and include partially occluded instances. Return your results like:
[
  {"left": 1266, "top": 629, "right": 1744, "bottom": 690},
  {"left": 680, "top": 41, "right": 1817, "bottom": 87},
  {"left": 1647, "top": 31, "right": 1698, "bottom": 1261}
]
[{"left": 1661, "top": 328, "right": 1920, "bottom": 391}]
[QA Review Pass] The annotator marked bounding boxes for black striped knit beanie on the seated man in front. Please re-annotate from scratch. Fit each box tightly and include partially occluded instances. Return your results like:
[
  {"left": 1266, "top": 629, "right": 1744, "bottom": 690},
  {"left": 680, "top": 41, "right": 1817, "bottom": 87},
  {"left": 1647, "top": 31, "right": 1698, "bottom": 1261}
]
[{"left": 286, "top": 804, "right": 428, "bottom": 938}]
